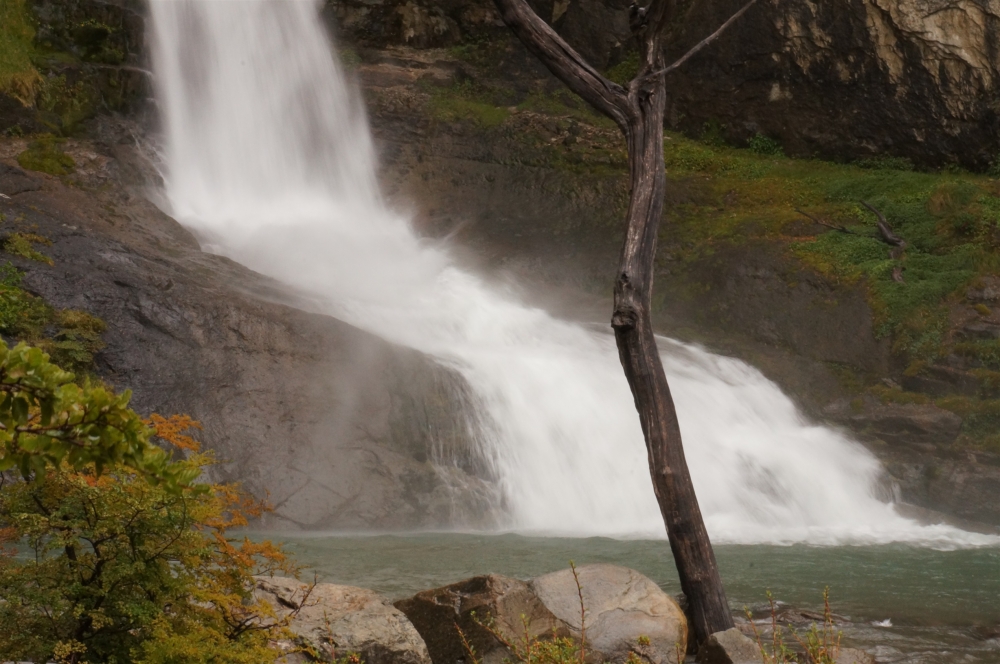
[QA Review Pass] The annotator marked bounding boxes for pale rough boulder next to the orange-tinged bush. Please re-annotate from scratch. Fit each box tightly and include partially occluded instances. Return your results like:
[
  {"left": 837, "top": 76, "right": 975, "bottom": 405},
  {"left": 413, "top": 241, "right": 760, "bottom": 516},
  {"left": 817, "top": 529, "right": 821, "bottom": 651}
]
[{"left": 256, "top": 577, "right": 431, "bottom": 664}]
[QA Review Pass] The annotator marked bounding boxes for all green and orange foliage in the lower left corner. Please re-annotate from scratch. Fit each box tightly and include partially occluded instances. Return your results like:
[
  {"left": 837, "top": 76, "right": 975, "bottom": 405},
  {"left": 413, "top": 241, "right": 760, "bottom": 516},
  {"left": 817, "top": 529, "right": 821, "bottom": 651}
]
[{"left": 0, "top": 370, "right": 305, "bottom": 664}]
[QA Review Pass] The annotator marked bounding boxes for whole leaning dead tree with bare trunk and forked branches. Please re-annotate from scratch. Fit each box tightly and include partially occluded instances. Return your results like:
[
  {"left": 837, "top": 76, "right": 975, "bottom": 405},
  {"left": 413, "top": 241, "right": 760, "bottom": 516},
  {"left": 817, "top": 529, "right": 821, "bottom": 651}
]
[{"left": 495, "top": 0, "right": 756, "bottom": 642}]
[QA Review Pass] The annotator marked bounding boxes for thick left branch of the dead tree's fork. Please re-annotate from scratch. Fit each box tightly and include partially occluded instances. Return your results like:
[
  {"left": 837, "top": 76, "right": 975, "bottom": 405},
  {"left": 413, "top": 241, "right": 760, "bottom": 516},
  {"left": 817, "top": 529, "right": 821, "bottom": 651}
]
[{"left": 494, "top": 0, "right": 629, "bottom": 130}]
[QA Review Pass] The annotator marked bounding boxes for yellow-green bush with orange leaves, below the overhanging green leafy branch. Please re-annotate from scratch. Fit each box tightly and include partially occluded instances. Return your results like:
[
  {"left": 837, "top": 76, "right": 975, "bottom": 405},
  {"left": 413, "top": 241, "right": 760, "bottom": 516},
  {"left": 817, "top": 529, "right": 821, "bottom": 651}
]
[{"left": 0, "top": 418, "right": 294, "bottom": 664}]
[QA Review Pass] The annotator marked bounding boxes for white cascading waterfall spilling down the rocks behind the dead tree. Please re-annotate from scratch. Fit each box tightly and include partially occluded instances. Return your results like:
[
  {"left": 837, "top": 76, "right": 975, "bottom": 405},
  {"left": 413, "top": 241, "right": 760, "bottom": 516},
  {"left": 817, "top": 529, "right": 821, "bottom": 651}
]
[{"left": 151, "top": 0, "right": 988, "bottom": 545}]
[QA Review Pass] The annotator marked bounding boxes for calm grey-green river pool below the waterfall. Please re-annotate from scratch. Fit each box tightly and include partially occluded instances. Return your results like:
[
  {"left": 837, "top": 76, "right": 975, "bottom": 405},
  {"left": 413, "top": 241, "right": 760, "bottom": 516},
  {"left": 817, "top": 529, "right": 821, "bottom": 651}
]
[{"left": 281, "top": 533, "right": 1000, "bottom": 664}]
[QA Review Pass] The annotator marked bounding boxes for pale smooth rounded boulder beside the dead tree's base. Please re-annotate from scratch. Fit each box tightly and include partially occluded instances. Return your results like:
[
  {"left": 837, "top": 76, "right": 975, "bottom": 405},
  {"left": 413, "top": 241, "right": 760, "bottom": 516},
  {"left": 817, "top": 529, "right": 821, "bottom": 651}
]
[{"left": 531, "top": 564, "right": 687, "bottom": 664}]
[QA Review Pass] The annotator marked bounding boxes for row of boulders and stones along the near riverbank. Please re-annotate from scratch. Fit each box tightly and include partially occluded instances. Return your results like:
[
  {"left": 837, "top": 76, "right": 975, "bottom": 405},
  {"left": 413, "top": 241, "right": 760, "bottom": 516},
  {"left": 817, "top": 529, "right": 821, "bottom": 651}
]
[{"left": 257, "top": 564, "right": 875, "bottom": 664}]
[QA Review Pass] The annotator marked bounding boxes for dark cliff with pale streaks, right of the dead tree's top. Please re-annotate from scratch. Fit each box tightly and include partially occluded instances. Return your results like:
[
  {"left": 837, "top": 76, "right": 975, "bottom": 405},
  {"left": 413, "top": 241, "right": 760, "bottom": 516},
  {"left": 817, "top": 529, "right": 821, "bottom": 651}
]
[{"left": 670, "top": 0, "right": 1000, "bottom": 168}]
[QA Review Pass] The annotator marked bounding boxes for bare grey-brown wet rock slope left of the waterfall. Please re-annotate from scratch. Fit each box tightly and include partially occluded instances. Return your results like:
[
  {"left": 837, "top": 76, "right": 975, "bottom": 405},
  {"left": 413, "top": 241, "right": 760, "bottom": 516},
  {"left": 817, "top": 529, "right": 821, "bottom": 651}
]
[{"left": 0, "top": 137, "right": 498, "bottom": 529}]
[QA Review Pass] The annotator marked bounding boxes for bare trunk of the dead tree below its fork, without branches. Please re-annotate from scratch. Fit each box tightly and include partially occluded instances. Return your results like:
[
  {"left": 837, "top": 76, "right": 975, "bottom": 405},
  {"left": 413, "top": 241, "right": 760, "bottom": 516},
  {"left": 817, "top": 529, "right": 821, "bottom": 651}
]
[{"left": 611, "top": 74, "right": 733, "bottom": 643}]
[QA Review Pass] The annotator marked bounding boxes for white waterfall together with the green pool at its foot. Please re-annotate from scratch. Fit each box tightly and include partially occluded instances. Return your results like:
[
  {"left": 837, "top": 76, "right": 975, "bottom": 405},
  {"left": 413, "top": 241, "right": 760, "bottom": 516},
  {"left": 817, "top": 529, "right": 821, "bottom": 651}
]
[{"left": 151, "top": 0, "right": 1000, "bottom": 662}]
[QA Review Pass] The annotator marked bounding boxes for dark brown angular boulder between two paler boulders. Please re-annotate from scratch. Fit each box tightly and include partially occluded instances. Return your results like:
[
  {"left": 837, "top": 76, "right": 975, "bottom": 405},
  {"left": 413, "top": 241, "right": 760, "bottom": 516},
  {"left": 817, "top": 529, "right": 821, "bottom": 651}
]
[{"left": 395, "top": 574, "right": 569, "bottom": 664}]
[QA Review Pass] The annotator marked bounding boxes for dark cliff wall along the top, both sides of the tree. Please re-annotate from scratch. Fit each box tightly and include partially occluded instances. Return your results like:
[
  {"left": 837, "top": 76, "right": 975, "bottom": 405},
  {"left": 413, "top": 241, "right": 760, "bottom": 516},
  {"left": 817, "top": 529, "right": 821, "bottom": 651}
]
[{"left": 327, "top": 0, "right": 1000, "bottom": 169}]
